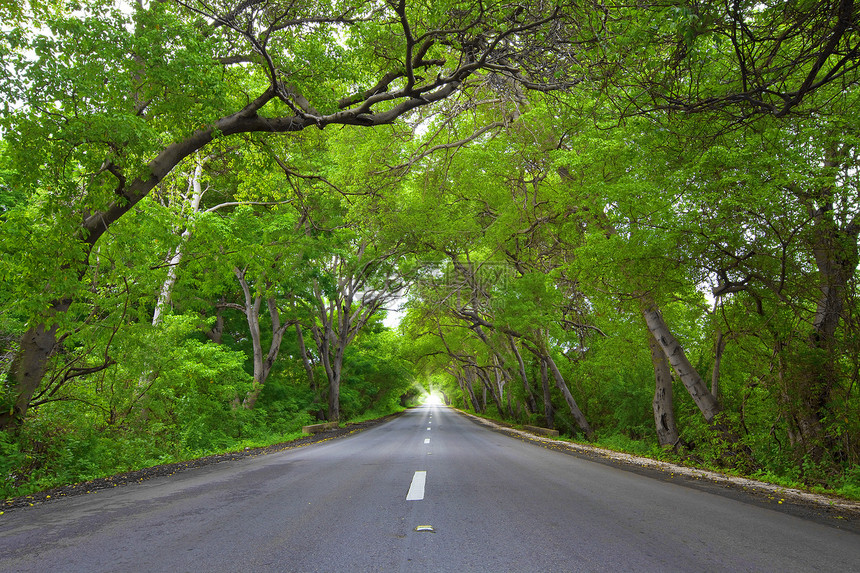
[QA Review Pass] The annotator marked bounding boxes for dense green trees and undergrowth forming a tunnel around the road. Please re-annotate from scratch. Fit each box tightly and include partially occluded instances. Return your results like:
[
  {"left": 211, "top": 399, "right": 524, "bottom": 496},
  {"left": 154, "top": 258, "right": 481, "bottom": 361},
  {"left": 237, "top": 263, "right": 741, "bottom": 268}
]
[{"left": 0, "top": 0, "right": 860, "bottom": 495}]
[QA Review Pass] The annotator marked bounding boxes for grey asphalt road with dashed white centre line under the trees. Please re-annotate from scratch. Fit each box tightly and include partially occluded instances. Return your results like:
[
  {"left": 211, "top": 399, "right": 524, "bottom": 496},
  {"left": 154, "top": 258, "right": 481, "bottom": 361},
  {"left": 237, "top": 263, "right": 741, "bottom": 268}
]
[{"left": 0, "top": 407, "right": 860, "bottom": 573}]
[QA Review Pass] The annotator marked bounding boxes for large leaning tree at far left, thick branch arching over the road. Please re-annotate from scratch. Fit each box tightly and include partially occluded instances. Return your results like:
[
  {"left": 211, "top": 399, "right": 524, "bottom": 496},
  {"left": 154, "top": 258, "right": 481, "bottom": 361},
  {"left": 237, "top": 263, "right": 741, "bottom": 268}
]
[{"left": 0, "top": 1, "right": 584, "bottom": 427}]
